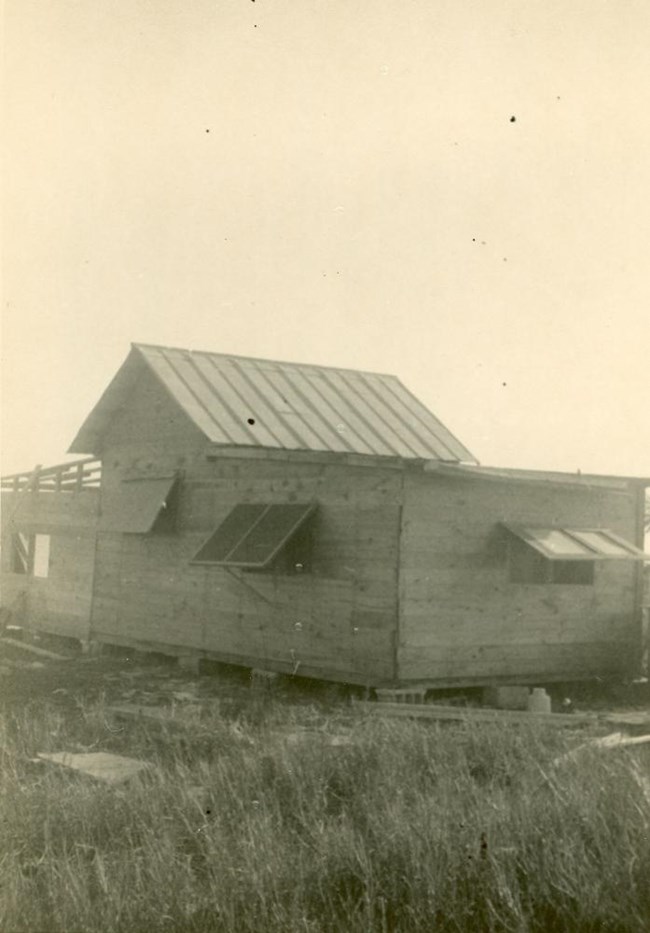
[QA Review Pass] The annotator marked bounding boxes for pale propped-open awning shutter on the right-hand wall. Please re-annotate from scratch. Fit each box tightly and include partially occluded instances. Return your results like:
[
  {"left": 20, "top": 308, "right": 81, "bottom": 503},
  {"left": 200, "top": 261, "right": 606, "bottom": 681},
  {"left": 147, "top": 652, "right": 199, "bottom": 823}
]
[{"left": 505, "top": 524, "right": 650, "bottom": 561}]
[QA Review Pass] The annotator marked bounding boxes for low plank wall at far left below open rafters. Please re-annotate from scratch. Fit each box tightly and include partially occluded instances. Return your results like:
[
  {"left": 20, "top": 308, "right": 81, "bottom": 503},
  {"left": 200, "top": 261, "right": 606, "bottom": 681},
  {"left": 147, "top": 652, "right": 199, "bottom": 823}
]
[{"left": 1, "top": 490, "right": 99, "bottom": 640}]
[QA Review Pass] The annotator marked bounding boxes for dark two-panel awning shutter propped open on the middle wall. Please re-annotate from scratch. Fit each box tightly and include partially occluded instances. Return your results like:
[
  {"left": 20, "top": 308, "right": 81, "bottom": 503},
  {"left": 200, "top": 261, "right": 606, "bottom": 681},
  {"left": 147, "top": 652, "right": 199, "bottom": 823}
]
[{"left": 192, "top": 503, "right": 315, "bottom": 569}]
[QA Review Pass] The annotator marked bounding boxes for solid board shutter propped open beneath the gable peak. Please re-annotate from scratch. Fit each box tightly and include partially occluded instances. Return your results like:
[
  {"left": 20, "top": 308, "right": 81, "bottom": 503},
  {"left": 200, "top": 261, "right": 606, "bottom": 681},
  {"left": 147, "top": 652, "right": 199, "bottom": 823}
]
[{"left": 99, "top": 474, "right": 178, "bottom": 534}]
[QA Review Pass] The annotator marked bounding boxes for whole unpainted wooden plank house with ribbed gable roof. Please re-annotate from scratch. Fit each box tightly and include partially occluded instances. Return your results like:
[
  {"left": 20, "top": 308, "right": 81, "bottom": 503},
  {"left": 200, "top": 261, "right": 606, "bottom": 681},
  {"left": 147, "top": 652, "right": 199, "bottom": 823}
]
[{"left": 2, "top": 345, "right": 650, "bottom": 686}]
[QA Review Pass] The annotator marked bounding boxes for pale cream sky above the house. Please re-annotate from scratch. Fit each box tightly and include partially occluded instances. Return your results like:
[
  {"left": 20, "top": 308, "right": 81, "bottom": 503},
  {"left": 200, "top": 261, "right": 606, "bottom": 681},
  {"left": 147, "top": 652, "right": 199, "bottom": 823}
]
[{"left": 2, "top": 0, "right": 650, "bottom": 476}]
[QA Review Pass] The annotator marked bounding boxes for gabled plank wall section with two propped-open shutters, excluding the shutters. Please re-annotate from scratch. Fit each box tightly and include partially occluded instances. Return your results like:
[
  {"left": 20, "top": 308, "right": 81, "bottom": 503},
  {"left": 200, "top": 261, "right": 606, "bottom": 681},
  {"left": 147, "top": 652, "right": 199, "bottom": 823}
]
[{"left": 92, "top": 366, "right": 402, "bottom": 683}]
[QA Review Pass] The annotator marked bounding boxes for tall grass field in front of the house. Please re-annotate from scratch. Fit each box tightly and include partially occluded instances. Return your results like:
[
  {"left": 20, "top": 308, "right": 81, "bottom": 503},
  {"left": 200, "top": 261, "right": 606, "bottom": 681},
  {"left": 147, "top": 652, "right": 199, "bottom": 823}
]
[{"left": 0, "top": 656, "right": 650, "bottom": 933}]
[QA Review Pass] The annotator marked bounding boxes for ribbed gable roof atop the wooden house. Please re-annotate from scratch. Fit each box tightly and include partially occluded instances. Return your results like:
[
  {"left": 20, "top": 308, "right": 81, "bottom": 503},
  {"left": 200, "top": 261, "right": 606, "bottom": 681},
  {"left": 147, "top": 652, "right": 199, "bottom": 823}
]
[{"left": 70, "top": 344, "right": 476, "bottom": 463}]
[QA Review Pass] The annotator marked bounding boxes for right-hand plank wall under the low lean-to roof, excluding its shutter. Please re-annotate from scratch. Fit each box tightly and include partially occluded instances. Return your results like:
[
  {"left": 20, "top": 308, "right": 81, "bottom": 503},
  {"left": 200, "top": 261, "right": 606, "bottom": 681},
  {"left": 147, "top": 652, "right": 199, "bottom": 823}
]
[{"left": 398, "top": 472, "right": 640, "bottom": 683}]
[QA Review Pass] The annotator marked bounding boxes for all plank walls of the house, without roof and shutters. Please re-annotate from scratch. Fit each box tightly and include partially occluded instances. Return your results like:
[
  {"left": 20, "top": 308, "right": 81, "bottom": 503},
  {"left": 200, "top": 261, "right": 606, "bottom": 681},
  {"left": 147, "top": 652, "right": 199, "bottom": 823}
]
[{"left": 6, "top": 356, "right": 640, "bottom": 685}]
